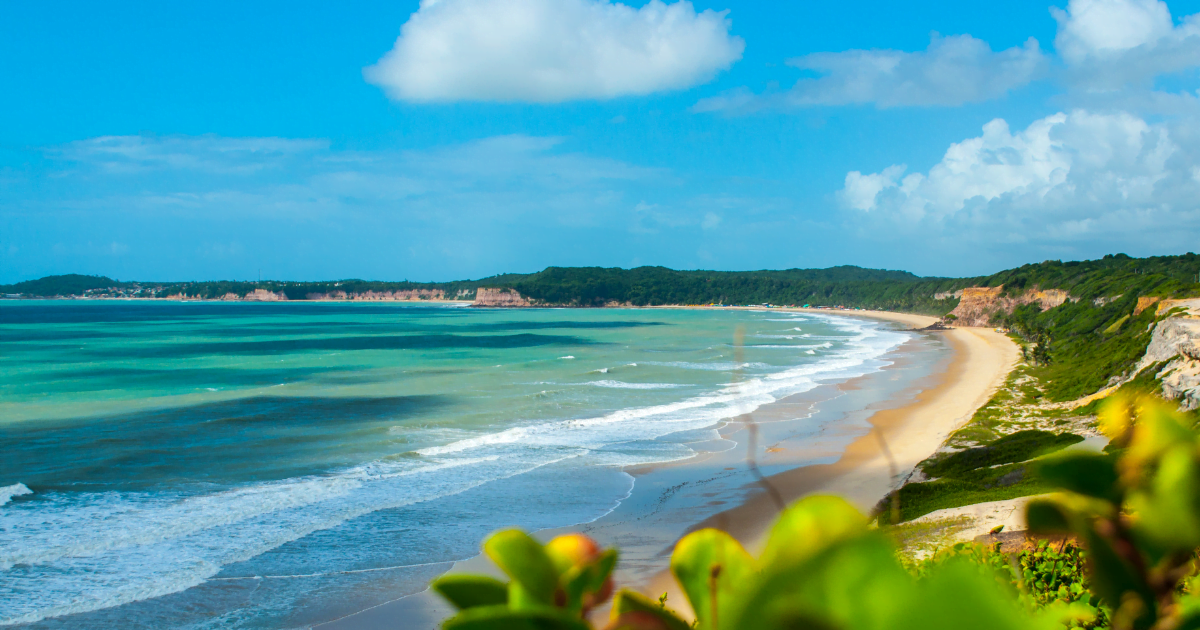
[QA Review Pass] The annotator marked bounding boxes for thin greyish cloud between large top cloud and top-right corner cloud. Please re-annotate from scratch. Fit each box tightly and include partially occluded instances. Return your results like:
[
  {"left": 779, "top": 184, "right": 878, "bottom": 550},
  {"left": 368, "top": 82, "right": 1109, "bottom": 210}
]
[{"left": 696, "top": 35, "right": 1046, "bottom": 112}]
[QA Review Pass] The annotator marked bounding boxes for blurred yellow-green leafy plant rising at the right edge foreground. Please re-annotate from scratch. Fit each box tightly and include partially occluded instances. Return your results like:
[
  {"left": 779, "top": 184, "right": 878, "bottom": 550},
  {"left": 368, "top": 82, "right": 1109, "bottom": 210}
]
[{"left": 1027, "top": 396, "right": 1200, "bottom": 629}]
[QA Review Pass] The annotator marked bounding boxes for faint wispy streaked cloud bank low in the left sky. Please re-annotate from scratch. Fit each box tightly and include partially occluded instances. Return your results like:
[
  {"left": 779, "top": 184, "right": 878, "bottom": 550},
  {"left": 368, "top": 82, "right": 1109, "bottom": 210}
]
[{"left": 39, "top": 134, "right": 673, "bottom": 229}]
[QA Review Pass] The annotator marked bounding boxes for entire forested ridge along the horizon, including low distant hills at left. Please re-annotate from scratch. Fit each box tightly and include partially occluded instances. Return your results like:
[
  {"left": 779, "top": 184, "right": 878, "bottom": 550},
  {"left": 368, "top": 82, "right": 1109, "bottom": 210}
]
[{"left": 0, "top": 253, "right": 1200, "bottom": 314}]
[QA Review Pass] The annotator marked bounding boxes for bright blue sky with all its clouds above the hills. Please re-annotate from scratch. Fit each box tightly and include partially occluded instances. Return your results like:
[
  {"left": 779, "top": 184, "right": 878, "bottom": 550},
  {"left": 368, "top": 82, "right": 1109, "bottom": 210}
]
[{"left": 0, "top": 0, "right": 1200, "bottom": 282}]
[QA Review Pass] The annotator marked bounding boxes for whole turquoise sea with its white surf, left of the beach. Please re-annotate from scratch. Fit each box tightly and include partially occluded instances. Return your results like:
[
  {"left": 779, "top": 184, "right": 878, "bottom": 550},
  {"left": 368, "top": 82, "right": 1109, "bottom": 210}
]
[{"left": 0, "top": 301, "right": 907, "bottom": 628}]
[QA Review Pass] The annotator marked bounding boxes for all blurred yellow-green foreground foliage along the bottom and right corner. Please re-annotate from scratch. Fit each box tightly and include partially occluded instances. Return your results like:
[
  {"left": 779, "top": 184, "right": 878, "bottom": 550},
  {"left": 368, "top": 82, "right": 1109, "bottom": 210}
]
[{"left": 433, "top": 397, "right": 1200, "bottom": 630}]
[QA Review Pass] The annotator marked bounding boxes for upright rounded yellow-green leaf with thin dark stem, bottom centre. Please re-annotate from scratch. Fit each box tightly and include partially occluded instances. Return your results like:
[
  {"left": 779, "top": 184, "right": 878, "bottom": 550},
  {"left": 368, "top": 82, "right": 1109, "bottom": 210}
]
[{"left": 671, "top": 529, "right": 756, "bottom": 630}]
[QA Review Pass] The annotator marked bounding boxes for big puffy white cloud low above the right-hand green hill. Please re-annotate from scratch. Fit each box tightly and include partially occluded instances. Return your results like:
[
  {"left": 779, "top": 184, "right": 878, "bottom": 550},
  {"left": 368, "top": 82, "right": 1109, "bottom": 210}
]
[{"left": 839, "top": 110, "right": 1200, "bottom": 241}]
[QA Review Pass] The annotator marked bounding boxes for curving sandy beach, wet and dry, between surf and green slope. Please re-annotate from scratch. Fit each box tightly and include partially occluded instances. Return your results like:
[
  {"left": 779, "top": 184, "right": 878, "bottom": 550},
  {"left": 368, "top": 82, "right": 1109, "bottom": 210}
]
[{"left": 324, "top": 308, "right": 1019, "bottom": 630}]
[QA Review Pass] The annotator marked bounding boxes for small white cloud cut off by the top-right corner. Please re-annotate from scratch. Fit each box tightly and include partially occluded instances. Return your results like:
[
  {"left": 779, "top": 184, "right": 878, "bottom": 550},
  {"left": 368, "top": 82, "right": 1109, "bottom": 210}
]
[{"left": 1051, "top": 0, "right": 1200, "bottom": 89}]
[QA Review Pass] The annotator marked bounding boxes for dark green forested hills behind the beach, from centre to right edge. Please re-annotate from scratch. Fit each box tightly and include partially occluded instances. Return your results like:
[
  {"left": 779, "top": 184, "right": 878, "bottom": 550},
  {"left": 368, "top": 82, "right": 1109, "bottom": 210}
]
[{"left": 484, "top": 253, "right": 1200, "bottom": 314}]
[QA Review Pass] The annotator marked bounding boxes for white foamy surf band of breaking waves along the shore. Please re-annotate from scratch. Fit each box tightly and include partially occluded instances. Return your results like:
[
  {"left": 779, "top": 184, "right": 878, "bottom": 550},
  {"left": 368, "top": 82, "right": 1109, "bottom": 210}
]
[{"left": 0, "top": 309, "right": 907, "bottom": 625}]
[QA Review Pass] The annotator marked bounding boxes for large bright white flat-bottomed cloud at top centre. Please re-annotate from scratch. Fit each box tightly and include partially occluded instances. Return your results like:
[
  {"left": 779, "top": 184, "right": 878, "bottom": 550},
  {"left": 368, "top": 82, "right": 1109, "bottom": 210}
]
[{"left": 364, "top": 0, "right": 744, "bottom": 103}]
